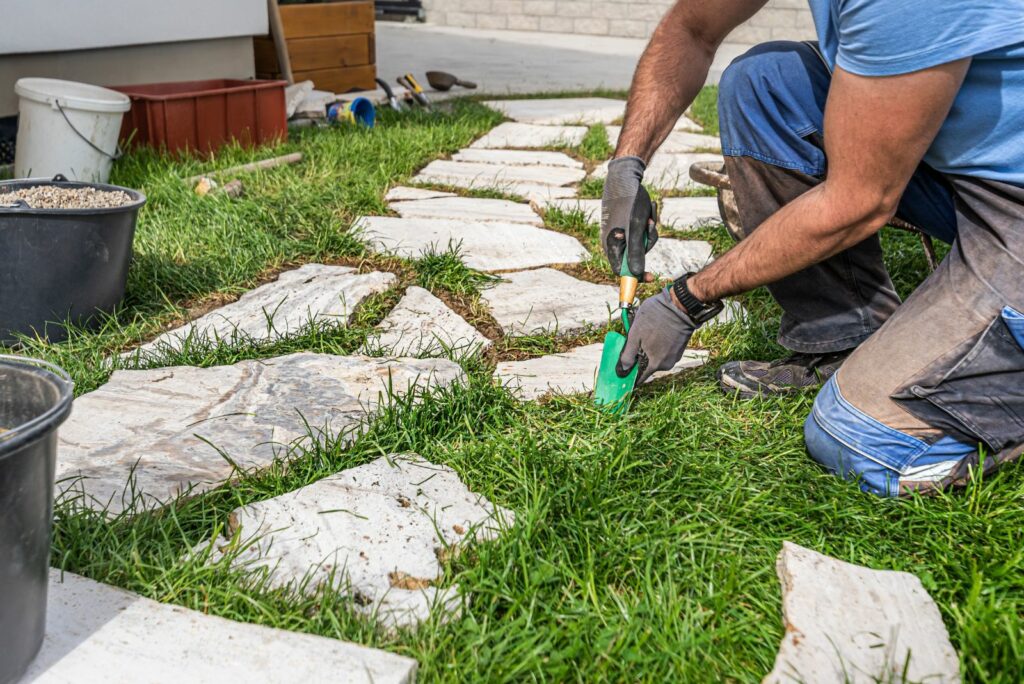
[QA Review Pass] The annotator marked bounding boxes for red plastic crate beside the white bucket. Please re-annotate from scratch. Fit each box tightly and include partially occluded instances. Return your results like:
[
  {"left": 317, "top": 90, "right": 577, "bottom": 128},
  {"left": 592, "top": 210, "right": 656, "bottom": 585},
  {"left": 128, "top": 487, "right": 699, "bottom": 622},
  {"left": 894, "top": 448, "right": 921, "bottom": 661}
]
[{"left": 113, "top": 79, "right": 288, "bottom": 153}]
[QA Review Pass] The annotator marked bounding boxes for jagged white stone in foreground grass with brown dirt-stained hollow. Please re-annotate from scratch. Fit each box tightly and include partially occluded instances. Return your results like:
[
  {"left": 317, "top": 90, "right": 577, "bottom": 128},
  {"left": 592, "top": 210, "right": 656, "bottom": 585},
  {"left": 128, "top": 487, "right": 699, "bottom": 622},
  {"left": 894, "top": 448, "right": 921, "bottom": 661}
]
[{"left": 205, "top": 454, "right": 514, "bottom": 628}]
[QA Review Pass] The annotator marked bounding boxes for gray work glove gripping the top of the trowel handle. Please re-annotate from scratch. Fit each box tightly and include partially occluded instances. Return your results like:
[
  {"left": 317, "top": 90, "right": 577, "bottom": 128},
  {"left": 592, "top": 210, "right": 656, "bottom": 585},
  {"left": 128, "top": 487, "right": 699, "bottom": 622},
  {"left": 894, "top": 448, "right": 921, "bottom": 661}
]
[{"left": 601, "top": 157, "right": 657, "bottom": 282}]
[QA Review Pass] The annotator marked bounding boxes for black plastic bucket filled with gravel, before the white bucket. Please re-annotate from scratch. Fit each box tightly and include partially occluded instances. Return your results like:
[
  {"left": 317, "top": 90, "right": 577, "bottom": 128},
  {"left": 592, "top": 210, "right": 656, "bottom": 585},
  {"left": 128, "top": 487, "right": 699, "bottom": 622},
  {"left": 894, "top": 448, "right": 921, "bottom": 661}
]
[{"left": 0, "top": 176, "right": 145, "bottom": 344}]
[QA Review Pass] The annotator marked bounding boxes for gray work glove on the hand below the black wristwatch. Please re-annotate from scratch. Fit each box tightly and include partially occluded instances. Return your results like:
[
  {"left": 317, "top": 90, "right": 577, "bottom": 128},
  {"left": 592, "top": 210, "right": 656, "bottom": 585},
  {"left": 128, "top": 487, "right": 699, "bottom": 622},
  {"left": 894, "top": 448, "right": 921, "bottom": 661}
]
[{"left": 615, "top": 288, "right": 697, "bottom": 386}]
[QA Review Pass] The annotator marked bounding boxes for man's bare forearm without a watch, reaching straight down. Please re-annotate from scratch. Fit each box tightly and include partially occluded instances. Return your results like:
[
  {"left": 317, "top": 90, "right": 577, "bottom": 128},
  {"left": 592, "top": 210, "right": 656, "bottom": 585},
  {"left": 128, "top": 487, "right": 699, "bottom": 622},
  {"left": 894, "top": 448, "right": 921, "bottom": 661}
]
[{"left": 615, "top": 0, "right": 766, "bottom": 163}]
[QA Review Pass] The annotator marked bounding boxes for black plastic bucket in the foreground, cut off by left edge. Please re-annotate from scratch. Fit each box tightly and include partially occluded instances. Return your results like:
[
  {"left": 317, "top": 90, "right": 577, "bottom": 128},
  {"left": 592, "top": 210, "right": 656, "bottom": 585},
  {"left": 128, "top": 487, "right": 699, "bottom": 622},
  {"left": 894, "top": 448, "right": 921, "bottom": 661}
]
[{"left": 0, "top": 354, "right": 74, "bottom": 684}]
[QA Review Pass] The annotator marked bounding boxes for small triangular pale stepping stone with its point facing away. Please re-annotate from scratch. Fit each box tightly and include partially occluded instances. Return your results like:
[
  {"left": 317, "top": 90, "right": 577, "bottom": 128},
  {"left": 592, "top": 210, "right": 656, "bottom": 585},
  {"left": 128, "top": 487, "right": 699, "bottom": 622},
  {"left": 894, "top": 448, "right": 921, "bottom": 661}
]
[{"left": 364, "top": 287, "right": 490, "bottom": 356}]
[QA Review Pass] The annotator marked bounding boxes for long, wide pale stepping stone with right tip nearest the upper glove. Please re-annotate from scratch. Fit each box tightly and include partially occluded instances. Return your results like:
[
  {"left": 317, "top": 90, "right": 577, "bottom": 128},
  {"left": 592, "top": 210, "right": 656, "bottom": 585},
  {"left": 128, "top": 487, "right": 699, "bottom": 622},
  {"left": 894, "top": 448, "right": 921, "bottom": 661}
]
[{"left": 355, "top": 216, "right": 590, "bottom": 271}]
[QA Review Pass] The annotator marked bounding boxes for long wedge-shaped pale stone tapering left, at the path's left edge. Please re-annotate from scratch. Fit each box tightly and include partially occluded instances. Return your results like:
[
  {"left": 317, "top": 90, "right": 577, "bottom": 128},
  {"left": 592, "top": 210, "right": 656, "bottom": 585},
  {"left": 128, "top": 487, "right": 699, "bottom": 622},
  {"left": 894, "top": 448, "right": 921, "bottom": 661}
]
[{"left": 122, "top": 263, "right": 396, "bottom": 360}]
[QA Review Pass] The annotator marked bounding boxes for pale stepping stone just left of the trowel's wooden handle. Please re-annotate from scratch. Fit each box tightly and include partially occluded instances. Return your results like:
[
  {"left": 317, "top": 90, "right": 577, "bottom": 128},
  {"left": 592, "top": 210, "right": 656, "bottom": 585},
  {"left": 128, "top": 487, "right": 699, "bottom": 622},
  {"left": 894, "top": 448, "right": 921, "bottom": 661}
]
[{"left": 481, "top": 268, "right": 618, "bottom": 336}]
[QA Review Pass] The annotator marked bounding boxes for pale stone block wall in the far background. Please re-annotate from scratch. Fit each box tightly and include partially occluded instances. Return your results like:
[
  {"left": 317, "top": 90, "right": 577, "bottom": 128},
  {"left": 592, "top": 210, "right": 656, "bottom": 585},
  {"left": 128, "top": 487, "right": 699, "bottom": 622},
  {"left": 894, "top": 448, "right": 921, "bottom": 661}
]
[{"left": 423, "top": 0, "right": 814, "bottom": 44}]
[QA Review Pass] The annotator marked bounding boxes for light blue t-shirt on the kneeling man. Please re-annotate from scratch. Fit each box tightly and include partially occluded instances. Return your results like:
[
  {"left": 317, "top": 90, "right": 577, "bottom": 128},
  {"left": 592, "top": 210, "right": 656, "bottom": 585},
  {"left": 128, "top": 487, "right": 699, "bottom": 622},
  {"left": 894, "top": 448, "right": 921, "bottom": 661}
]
[{"left": 809, "top": 0, "right": 1024, "bottom": 185}]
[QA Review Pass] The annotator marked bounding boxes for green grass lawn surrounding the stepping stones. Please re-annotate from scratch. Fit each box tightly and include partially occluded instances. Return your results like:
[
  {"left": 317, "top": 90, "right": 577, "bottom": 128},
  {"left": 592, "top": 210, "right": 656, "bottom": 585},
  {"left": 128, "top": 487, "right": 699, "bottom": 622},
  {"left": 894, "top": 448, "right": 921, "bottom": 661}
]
[{"left": 22, "top": 90, "right": 1024, "bottom": 682}]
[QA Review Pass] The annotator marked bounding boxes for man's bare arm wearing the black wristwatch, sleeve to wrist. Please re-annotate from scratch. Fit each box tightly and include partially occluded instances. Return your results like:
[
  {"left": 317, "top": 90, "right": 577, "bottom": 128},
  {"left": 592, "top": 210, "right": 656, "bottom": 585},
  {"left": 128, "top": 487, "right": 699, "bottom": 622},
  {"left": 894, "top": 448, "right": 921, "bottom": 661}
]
[{"left": 677, "top": 59, "right": 971, "bottom": 303}]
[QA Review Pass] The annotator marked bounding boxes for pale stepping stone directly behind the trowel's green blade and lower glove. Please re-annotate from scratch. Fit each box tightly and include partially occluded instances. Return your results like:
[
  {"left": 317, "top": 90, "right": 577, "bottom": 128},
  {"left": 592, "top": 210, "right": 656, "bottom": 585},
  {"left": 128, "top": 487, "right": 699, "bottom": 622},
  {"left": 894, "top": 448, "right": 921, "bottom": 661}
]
[{"left": 495, "top": 343, "right": 709, "bottom": 401}]
